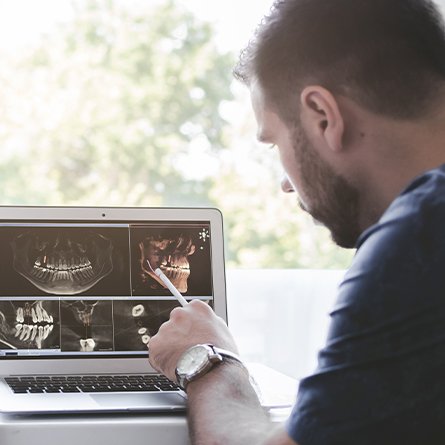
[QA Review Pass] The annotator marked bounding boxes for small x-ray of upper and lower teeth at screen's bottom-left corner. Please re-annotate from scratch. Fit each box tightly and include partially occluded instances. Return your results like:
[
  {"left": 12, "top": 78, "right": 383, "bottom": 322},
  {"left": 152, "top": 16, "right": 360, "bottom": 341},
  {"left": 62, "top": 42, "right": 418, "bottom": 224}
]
[{"left": 0, "top": 300, "right": 60, "bottom": 350}]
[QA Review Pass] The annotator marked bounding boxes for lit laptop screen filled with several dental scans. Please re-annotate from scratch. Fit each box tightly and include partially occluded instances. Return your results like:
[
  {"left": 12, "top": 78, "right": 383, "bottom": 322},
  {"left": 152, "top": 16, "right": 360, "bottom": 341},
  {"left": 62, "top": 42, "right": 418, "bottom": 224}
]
[{"left": 0, "top": 220, "right": 214, "bottom": 359}]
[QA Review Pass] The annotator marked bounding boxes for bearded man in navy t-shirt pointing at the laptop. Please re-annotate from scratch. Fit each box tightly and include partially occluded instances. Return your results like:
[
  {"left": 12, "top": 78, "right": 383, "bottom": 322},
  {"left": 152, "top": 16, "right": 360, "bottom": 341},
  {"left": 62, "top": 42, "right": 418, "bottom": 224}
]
[{"left": 149, "top": 0, "right": 445, "bottom": 445}]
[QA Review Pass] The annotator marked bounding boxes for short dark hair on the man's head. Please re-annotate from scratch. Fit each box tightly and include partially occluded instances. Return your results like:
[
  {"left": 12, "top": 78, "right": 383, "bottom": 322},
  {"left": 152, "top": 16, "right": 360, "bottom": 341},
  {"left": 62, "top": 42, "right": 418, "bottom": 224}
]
[{"left": 234, "top": 0, "right": 445, "bottom": 121}]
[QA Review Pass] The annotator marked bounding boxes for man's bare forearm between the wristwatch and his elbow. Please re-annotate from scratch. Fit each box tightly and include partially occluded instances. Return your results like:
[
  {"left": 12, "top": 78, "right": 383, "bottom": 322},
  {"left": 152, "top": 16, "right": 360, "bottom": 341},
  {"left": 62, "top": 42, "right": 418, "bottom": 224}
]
[{"left": 187, "top": 361, "right": 272, "bottom": 445}]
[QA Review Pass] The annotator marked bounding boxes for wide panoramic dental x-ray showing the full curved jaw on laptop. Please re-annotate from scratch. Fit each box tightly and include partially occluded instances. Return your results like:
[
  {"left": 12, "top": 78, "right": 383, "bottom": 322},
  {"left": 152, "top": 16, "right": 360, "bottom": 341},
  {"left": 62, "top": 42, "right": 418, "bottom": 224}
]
[{"left": 0, "top": 227, "right": 130, "bottom": 296}]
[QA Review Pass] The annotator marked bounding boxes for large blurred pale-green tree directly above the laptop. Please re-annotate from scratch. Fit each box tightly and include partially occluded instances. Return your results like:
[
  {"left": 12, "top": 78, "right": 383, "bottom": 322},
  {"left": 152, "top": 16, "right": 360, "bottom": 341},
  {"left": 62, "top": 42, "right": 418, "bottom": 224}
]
[{"left": 2, "top": 0, "right": 233, "bottom": 205}]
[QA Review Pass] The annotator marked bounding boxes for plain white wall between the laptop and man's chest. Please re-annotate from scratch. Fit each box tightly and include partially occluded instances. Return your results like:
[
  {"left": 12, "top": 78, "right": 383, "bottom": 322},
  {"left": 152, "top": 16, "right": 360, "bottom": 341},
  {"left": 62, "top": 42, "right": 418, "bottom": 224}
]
[{"left": 227, "top": 270, "right": 344, "bottom": 378}]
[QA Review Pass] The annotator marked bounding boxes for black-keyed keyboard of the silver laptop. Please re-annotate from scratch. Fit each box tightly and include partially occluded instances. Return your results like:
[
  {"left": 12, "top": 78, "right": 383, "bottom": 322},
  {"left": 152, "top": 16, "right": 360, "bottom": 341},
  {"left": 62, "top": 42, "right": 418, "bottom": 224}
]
[{"left": 5, "top": 374, "right": 179, "bottom": 394}]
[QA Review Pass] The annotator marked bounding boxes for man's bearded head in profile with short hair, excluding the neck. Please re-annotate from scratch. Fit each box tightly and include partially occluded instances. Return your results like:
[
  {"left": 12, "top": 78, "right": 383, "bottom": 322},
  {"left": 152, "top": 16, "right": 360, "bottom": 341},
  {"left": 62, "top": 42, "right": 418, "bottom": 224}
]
[{"left": 235, "top": 0, "right": 445, "bottom": 247}]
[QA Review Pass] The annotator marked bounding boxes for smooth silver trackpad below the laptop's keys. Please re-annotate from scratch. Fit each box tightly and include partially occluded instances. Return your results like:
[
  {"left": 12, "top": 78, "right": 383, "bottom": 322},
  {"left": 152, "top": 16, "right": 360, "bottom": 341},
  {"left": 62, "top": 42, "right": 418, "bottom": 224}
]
[{"left": 91, "top": 392, "right": 186, "bottom": 411}]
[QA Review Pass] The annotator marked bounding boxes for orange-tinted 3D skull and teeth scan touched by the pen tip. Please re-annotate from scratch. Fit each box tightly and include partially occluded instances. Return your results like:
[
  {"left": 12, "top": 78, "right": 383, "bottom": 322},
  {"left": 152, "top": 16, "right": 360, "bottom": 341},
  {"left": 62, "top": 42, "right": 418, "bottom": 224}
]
[{"left": 130, "top": 225, "right": 212, "bottom": 296}]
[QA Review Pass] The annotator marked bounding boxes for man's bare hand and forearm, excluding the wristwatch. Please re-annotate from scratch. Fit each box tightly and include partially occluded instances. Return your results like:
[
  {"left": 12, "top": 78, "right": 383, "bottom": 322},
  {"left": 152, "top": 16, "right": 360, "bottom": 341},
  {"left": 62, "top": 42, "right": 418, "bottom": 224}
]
[{"left": 149, "top": 301, "right": 295, "bottom": 445}]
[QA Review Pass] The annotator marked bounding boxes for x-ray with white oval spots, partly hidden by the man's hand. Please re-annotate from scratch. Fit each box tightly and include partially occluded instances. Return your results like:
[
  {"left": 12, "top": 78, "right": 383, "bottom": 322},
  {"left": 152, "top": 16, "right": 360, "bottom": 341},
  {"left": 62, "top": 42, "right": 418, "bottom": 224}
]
[{"left": 114, "top": 300, "right": 179, "bottom": 351}]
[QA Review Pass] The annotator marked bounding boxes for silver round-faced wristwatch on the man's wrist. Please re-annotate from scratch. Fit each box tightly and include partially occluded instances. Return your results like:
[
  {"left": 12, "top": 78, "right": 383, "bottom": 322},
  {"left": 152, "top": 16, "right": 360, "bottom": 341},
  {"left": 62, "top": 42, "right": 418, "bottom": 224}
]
[{"left": 176, "top": 344, "right": 242, "bottom": 391}]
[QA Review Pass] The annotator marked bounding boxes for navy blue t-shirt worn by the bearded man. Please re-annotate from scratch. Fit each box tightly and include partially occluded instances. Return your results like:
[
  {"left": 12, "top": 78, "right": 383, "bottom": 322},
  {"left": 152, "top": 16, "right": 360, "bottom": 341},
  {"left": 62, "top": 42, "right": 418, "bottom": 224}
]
[{"left": 287, "top": 166, "right": 445, "bottom": 445}]
